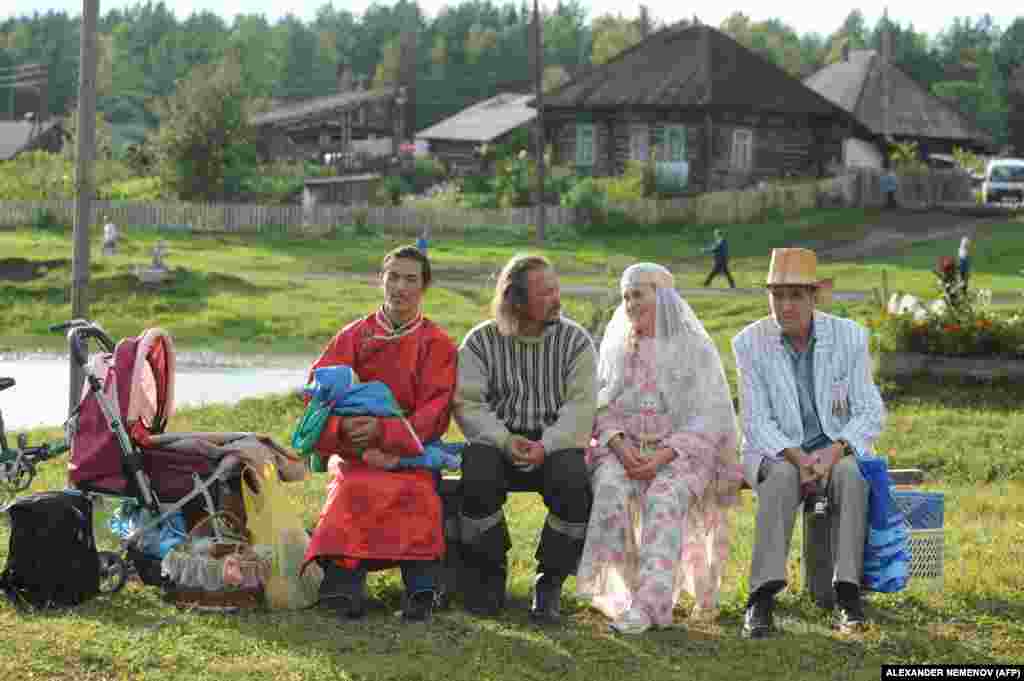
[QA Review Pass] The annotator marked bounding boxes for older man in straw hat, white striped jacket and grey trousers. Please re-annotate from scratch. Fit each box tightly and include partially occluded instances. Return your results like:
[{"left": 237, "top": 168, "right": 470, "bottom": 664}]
[{"left": 732, "top": 248, "right": 885, "bottom": 638}]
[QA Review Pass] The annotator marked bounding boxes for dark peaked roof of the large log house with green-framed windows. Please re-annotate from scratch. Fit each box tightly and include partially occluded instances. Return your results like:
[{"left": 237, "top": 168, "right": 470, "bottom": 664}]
[{"left": 544, "top": 26, "right": 846, "bottom": 117}]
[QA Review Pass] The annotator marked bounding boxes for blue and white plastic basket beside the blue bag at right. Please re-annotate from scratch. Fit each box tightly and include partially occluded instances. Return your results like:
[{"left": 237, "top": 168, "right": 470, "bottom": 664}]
[{"left": 893, "top": 490, "right": 945, "bottom": 589}]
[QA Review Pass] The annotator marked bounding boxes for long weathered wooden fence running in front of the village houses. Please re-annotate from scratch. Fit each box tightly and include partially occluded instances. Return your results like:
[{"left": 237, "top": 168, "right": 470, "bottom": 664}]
[{"left": 0, "top": 169, "right": 973, "bottom": 236}]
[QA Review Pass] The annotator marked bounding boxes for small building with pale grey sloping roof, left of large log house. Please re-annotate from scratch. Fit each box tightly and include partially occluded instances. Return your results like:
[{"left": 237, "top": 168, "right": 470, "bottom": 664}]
[{"left": 416, "top": 92, "right": 537, "bottom": 175}]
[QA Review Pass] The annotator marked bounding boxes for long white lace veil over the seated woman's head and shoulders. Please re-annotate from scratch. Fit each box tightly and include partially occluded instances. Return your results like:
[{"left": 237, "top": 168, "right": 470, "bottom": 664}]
[{"left": 597, "top": 262, "right": 736, "bottom": 443}]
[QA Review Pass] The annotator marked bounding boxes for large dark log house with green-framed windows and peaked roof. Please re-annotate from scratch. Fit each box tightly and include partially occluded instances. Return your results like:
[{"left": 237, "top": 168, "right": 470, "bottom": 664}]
[{"left": 535, "top": 25, "right": 858, "bottom": 194}]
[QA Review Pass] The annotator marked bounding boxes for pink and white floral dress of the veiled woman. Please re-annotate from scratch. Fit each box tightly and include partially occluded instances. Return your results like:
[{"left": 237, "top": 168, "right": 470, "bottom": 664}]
[{"left": 577, "top": 340, "right": 742, "bottom": 627}]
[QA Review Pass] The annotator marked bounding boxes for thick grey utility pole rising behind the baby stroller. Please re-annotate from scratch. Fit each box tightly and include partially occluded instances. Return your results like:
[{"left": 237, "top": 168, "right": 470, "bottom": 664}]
[{"left": 68, "top": 0, "right": 99, "bottom": 415}]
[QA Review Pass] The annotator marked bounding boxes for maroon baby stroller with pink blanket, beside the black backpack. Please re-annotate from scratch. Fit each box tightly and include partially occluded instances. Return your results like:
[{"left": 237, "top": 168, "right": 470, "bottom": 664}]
[{"left": 61, "top": 320, "right": 306, "bottom": 590}]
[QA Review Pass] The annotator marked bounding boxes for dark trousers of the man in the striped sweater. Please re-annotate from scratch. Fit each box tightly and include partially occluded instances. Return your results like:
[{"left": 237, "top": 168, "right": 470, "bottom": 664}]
[{"left": 461, "top": 438, "right": 591, "bottom": 578}]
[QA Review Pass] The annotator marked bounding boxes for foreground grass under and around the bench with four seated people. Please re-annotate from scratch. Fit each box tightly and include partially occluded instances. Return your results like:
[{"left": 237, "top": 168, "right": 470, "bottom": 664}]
[{"left": 0, "top": 288, "right": 1024, "bottom": 681}]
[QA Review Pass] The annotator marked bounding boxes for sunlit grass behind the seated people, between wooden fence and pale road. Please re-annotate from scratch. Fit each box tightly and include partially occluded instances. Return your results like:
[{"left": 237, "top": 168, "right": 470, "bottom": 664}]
[{"left": 0, "top": 209, "right": 1024, "bottom": 354}]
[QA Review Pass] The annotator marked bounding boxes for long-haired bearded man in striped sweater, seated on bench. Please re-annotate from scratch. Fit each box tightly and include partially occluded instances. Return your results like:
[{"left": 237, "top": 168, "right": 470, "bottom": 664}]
[{"left": 455, "top": 255, "right": 597, "bottom": 623}]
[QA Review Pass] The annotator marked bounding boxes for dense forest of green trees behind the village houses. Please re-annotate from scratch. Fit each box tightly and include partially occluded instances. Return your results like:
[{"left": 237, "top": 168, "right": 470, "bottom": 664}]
[{"left": 6, "top": 0, "right": 1024, "bottom": 150}]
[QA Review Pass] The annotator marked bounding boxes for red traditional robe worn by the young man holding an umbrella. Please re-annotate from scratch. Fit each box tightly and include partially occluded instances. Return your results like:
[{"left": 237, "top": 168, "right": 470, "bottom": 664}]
[{"left": 305, "top": 311, "right": 457, "bottom": 567}]
